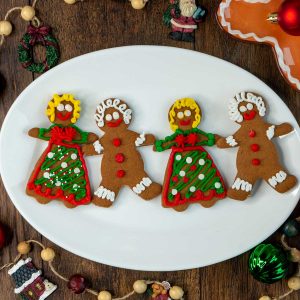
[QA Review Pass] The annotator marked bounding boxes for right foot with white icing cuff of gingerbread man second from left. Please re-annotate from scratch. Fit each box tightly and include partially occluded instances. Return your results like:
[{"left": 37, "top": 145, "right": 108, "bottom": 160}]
[{"left": 130, "top": 177, "right": 162, "bottom": 200}]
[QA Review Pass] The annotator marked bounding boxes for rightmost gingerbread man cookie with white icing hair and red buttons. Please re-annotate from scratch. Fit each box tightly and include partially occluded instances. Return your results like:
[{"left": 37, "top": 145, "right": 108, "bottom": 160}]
[{"left": 217, "top": 92, "right": 297, "bottom": 200}]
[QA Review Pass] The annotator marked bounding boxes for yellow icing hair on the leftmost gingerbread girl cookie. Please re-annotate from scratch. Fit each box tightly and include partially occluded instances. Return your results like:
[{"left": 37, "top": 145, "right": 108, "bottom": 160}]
[{"left": 46, "top": 94, "right": 81, "bottom": 124}]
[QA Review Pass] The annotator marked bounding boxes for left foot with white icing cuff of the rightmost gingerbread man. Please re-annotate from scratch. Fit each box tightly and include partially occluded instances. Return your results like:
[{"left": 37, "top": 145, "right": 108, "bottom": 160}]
[{"left": 227, "top": 173, "right": 257, "bottom": 201}]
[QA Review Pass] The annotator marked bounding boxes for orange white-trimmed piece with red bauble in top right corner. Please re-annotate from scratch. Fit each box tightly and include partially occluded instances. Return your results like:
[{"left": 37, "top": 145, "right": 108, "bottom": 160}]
[{"left": 218, "top": 0, "right": 300, "bottom": 90}]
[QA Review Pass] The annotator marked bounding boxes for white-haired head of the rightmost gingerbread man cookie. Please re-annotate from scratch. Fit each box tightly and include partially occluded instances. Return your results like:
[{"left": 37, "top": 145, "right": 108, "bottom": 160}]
[{"left": 229, "top": 92, "right": 266, "bottom": 123}]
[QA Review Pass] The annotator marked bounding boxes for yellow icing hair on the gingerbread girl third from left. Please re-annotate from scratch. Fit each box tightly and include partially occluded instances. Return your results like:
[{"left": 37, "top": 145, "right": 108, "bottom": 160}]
[{"left": 169, "top": 98, "right": 201, "bottom": 131}]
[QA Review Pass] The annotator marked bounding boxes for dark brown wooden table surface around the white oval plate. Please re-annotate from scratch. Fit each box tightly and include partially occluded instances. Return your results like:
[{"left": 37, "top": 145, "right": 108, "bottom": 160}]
[{"left": 0, "top": 0, "right": 300, "bottom": 300}]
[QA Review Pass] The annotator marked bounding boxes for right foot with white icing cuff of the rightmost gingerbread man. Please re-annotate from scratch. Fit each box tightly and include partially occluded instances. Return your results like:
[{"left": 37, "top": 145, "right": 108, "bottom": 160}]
[{"left": 264, "top": 167, "right": 297, "bottom": 193}]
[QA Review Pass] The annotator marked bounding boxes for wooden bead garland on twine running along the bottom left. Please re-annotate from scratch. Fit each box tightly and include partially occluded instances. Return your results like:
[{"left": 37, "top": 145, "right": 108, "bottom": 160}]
[{"left": 0, "top": 240, "right": 184, "bottom": 300}]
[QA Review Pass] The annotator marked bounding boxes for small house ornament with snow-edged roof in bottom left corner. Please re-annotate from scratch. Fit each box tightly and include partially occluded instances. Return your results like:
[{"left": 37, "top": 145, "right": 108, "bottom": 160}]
[{"left": 8, "top": 257, "right": 57, "bottom": 300}]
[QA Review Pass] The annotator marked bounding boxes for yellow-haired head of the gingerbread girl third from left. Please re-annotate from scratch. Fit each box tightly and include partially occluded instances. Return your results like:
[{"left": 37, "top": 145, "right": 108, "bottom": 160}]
[{"left": 169, "top": 98, "right": 201, "bottom": 131}]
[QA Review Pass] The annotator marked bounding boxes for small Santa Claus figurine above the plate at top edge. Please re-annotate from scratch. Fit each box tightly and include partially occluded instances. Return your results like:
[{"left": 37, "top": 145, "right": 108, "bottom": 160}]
[{"left": 163, "top": 0, "right": 207, "bottom": 42}]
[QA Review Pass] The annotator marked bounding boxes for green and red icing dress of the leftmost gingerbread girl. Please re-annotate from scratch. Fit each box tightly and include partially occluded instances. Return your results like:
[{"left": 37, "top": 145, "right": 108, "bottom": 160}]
[{"left": 27, "top": 124, "right": 91, "bottom": 206}]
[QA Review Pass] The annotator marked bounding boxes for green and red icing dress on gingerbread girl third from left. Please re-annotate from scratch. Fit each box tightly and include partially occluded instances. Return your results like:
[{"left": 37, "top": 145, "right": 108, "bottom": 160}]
[{"left": 155, "top": 128, "right": 226, "bottom": 207}]
